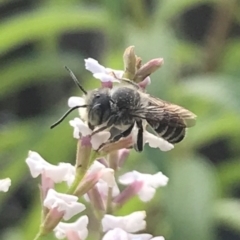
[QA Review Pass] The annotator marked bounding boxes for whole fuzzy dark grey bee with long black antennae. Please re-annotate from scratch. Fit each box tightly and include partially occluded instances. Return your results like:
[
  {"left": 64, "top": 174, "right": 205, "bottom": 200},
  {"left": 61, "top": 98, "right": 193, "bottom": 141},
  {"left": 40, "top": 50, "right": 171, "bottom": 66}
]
[{"left": 51, "top": 67, "right": 196, "bottom": 152}]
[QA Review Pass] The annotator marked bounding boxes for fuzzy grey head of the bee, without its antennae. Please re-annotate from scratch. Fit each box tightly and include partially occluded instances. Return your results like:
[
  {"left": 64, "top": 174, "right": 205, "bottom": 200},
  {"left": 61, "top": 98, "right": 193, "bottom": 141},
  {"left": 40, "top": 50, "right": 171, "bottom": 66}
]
[{"left": 86, "top": 88, "right": 111, "bottom": 126}]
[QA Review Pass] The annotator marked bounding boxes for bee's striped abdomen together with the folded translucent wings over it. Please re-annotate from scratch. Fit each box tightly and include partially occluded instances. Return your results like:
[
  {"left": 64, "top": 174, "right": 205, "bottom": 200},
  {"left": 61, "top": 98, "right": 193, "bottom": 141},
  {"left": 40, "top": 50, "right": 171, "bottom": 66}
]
[{"left": 145, "top": 96, "right": 196, "bottom": 143}]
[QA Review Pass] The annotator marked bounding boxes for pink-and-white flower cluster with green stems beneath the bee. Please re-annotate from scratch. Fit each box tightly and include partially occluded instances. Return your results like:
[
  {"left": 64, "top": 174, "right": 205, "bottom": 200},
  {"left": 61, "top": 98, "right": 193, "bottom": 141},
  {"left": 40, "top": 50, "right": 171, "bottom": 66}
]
[{"left": 24, "top": 47, "right": 173, "bottom": 240}]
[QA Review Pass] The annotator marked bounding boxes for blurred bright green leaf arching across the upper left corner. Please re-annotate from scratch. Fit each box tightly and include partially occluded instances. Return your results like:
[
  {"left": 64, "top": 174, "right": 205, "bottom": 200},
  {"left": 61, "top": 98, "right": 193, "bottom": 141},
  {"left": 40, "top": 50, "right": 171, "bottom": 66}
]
[{"left": 0, "top": 5, "right": 109, "bottom": 54}]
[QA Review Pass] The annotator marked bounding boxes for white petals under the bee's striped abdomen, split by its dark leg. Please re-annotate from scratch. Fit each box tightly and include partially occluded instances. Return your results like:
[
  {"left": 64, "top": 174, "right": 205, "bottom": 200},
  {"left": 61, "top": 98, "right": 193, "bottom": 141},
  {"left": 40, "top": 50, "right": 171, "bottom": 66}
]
[{"left": 132, "top": 126, "right": 174, "bottom": 151}]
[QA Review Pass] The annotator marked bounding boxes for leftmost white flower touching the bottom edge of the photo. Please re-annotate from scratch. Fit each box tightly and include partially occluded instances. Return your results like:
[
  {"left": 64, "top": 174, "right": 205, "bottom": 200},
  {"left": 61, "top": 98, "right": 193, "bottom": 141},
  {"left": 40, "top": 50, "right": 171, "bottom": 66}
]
[{"left": 54, "top": 216, "right": 88, "bottom": 240}]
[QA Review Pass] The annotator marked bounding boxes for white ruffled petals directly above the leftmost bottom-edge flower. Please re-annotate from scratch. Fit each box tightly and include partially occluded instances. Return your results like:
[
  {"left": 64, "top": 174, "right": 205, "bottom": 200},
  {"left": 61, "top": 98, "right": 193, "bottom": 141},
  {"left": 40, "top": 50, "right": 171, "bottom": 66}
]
[{"left": 43, "top": 189, "right": 86, "bottom": 220}]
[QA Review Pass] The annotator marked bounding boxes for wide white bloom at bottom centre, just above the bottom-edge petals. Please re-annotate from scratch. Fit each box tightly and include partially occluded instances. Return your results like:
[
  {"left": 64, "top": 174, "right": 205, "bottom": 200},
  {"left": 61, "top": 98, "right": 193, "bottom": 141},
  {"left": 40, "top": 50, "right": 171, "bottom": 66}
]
[{"left": 102, "top": 211, "right": 146, "bottom": 233}]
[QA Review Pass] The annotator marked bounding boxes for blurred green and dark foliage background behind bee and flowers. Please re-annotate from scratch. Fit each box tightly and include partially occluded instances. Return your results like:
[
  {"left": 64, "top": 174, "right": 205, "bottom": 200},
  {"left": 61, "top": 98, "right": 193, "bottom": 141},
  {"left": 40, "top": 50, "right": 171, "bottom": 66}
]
[{"left": 0, "top": 0, "right": 240, "bottom": 240}]
